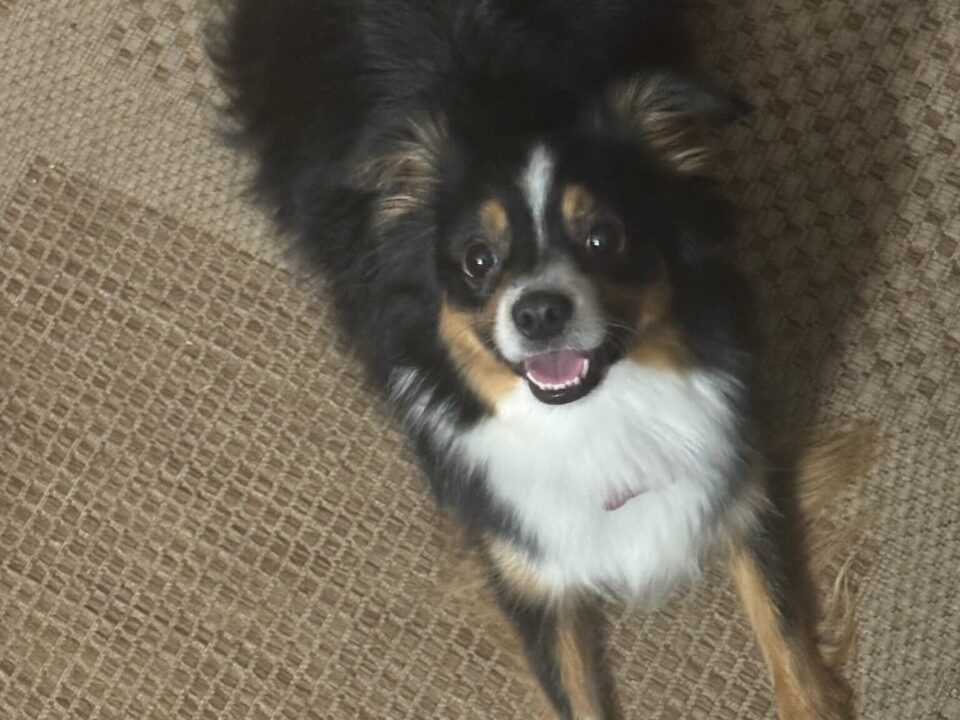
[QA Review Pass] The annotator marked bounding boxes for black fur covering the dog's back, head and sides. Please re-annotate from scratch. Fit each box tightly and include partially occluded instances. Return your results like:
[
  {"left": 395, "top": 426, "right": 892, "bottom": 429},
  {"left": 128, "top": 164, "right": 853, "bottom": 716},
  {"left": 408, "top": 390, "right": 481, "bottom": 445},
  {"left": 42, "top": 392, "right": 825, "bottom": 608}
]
[{"left": 212, "top": 0, "right": 772, "bottom": 717}]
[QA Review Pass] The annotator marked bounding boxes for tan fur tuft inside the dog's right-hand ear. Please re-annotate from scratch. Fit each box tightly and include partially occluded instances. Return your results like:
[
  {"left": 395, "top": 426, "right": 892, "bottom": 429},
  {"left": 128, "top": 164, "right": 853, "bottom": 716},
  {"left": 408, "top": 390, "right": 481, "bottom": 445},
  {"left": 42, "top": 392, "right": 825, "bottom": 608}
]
[{"left": 608, "top": 78, "right": 711, "bottom": 174}]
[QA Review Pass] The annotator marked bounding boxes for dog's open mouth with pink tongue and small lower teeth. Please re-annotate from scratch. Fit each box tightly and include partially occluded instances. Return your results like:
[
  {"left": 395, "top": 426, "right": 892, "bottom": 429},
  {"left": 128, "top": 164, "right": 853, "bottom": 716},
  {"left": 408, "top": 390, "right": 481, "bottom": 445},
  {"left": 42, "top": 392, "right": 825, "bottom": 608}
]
[{"left": 523, "top": 350, "right": 603, "bottom": 405}]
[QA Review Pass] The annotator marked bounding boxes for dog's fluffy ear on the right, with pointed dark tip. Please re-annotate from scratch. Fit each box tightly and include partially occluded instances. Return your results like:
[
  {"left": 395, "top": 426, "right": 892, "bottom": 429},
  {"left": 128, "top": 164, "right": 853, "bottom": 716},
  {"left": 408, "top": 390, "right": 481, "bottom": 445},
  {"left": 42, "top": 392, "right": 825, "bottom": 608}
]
[{"left": 606, "top": 71, "right": 750, "bottom": 175}]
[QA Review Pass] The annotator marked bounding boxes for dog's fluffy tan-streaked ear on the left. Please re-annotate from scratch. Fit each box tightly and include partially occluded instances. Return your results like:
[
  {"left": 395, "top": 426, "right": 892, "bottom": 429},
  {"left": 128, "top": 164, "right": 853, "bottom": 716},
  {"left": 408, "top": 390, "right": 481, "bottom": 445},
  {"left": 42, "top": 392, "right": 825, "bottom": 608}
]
[{"left": 356, "top": 117, "right": 447, "bottom": 226}]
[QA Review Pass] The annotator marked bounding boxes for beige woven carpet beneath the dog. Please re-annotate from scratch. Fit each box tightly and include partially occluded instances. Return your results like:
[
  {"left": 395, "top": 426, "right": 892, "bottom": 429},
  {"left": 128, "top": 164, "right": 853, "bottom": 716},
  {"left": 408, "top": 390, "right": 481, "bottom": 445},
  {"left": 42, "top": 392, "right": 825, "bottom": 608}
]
[{"left": 0, "top": 0, "right": 960, "bottom": 720}]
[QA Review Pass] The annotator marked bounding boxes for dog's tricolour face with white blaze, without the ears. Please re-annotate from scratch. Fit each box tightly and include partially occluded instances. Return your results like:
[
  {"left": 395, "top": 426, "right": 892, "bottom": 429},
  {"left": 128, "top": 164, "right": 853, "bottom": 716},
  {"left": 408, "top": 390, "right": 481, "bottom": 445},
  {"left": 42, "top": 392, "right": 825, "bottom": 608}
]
[{"left": 439, "top": 140, "right": 682, "bottom": 404}]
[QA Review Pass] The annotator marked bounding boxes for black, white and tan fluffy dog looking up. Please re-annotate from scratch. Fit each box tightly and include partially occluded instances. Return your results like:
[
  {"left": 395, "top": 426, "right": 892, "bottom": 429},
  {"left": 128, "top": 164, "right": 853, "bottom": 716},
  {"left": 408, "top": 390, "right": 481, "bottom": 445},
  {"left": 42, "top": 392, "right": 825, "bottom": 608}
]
[{"left": 213, "top": 0, "right": 848, "bottom": 720}]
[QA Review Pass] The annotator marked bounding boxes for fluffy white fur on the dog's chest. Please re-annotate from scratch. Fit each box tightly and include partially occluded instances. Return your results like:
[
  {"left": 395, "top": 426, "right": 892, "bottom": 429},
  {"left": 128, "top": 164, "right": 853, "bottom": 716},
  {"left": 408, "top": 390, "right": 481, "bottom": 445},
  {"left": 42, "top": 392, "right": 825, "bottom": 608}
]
[{"left": 459, "top": 361, "right": 737, "bottom": 604}]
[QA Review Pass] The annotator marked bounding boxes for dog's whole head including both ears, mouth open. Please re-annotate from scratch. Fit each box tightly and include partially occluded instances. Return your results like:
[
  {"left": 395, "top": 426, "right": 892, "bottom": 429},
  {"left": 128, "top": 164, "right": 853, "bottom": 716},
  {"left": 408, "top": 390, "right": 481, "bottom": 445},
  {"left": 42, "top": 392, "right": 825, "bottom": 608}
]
[{"left": 364, "top": 75, "right": 740, "bottom": 407}]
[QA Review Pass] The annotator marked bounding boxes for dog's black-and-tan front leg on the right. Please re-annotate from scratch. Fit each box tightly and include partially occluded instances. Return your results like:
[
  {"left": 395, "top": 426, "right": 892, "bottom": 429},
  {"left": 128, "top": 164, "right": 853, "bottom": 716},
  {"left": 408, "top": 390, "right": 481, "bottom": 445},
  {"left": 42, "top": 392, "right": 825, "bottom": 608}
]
[{"left": 731, "top": 511, "right": 852, "bottom": 720}]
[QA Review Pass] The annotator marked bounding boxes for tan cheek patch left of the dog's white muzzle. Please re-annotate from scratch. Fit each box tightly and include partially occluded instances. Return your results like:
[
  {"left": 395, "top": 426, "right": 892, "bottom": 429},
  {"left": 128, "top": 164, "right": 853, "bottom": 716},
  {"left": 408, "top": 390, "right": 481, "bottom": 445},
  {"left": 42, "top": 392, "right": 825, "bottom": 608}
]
[{"left": 440, "top": 300, "right": 520, "bottom": 412}]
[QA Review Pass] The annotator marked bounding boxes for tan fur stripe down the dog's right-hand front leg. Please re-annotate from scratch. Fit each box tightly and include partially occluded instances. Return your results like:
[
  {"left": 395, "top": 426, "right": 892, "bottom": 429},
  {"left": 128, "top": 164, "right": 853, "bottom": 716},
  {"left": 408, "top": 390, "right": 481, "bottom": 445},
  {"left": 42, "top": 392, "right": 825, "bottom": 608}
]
[{"left": 731, "top": 548, "right": 850, "bottom": 720}]
